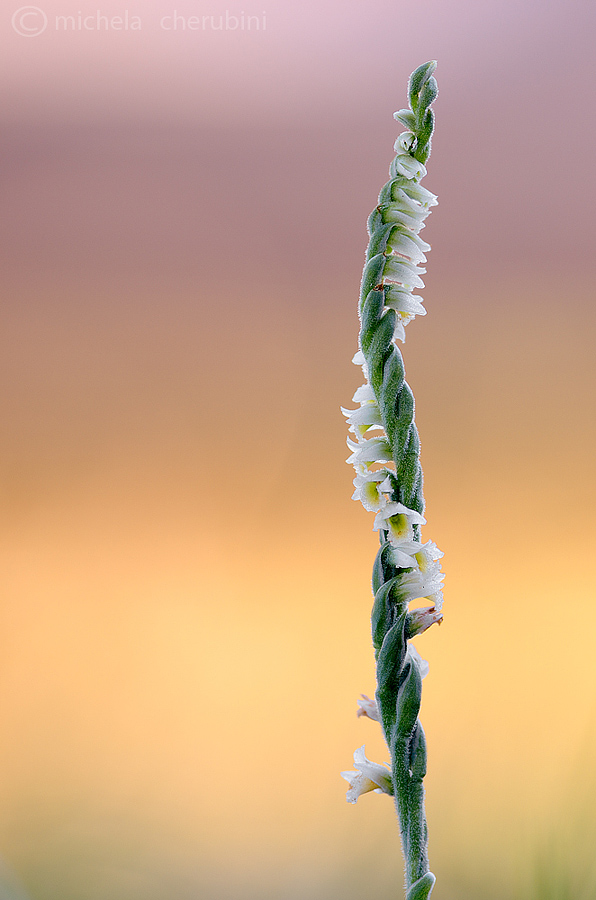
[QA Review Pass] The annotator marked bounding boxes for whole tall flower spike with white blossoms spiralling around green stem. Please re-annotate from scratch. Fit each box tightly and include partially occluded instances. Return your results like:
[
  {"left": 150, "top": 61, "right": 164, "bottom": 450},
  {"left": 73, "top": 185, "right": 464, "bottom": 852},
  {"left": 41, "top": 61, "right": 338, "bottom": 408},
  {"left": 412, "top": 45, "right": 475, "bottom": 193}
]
[{"left": 343, "top": 62, "right": 444, "bottom": 900}]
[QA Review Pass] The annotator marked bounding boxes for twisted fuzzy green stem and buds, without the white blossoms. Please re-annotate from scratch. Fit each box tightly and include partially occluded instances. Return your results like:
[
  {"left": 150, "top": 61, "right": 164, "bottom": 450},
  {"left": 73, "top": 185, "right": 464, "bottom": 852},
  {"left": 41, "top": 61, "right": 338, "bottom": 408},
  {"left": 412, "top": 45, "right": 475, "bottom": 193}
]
[{"left": 360, "top": 63, "right": 437, "bottom": 900}]
